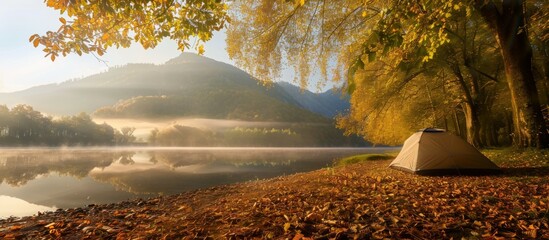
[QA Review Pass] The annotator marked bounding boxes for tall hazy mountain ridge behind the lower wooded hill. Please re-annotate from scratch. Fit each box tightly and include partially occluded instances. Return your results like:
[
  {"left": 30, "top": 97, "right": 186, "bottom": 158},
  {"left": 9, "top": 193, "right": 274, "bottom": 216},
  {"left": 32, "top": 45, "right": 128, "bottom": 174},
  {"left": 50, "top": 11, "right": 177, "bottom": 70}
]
[{"left": 0, "top": 53, "right": 346, "bottom": 120}]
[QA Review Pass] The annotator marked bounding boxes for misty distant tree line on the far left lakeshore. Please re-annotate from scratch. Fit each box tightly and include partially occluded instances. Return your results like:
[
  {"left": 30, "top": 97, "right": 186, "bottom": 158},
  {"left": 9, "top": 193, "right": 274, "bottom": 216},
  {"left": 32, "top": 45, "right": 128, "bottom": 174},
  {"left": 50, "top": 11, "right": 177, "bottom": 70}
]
[{"left": 0, "top": 105, "right": 135, "bottom": 146}]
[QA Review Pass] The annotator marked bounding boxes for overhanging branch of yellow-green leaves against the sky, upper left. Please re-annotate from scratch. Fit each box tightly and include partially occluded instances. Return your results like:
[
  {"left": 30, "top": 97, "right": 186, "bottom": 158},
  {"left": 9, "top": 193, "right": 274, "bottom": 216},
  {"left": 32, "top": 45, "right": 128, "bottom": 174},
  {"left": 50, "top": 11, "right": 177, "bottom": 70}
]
[{"left": 29, "top": 0, "right": 228, "bottom": 61}]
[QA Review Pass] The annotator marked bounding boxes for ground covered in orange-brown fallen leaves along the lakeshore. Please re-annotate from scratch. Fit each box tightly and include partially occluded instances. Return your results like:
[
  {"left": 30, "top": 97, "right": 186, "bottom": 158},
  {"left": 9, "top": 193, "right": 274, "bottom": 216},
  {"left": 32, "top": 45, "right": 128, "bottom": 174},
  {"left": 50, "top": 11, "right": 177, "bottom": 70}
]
[{"left": 0, "top": 151, "right": 549, "bottom": 239}]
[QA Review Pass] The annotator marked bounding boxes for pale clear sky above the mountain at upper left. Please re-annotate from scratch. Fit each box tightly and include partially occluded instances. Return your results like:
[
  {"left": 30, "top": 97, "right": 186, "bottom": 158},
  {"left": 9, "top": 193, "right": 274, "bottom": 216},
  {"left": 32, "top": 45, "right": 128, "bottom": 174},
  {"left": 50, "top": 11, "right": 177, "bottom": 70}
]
[{"left": 0, "top": 0, "right": 234, "bottom": 92}]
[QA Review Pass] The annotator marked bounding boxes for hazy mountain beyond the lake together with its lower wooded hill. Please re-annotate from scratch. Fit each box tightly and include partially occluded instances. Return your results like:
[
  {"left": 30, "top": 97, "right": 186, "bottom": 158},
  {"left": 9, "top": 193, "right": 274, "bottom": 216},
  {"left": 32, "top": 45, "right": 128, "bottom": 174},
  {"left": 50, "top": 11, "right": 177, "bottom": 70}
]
[{"left": 0, "top": 53, "right": 343, "bottom": 122}]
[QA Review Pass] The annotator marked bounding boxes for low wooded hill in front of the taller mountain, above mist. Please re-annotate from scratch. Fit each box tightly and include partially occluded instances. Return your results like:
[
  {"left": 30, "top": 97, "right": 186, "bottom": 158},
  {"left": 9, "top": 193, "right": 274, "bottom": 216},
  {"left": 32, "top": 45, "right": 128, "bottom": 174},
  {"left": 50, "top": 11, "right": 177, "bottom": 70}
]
[{"left": 94, "top": 87, "right": 328, "bottom": 122}]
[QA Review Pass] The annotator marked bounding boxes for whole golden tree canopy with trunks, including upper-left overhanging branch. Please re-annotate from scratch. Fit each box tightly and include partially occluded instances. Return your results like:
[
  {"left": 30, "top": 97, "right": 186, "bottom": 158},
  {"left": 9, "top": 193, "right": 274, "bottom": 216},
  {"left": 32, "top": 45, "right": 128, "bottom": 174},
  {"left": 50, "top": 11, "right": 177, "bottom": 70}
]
[{"left": 36, "top": 0, "right": 549, "bottom": 148}]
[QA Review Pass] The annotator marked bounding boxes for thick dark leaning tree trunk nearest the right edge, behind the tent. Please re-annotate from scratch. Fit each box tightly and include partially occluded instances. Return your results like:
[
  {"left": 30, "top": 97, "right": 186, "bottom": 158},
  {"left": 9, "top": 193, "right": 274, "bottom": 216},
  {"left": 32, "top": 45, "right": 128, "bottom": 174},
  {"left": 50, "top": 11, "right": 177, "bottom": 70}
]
[{"left": 475, "top": 0, "right": 549, "bottom": 148}]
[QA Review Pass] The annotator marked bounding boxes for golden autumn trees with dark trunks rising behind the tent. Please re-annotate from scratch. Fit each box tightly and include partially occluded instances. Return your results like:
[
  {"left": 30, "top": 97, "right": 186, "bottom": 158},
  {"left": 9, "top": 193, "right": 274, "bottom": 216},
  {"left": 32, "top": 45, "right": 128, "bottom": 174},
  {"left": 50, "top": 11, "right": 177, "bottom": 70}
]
[{"left": 227, "top": 0, "right": 549, "bottom": 148}]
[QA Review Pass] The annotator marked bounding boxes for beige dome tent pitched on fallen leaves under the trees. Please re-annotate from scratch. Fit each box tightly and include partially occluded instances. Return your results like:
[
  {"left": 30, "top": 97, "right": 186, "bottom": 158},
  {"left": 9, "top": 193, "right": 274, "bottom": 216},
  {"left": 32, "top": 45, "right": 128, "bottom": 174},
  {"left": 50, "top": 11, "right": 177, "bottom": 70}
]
[{"left": 389, "top": 128, "right": 499, "bottom": 175}]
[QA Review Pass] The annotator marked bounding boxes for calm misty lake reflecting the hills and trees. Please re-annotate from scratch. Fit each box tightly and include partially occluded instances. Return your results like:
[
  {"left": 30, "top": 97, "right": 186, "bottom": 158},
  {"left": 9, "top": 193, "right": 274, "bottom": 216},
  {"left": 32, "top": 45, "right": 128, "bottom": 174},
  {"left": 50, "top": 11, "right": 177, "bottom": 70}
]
[{"left": 0, "top": 147, "right": 396, "bottom": 218}]
